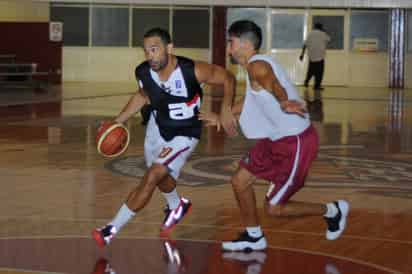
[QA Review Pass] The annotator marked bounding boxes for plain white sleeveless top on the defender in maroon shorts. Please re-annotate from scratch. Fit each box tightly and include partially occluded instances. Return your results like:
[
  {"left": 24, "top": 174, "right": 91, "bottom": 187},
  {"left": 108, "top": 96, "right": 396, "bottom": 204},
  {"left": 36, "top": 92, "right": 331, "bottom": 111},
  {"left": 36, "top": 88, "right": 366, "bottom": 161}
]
[{"left": 239, "top": 55, "right": 310, "bottom": 141}]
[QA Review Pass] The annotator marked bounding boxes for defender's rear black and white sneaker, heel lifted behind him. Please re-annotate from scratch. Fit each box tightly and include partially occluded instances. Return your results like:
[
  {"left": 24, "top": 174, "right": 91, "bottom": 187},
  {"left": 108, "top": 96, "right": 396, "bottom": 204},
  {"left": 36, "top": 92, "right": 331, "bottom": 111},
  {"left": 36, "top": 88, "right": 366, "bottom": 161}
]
[{"left": 325, "top": 200, "right": 349, "bottom": 240}]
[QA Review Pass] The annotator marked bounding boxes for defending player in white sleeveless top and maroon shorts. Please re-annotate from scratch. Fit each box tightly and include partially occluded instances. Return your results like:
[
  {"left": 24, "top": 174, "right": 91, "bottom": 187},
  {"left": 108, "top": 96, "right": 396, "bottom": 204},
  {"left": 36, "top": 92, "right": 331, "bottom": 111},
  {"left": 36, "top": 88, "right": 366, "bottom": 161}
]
[{"left": 200, "top": 20, "right": 349, "bottom": 251}]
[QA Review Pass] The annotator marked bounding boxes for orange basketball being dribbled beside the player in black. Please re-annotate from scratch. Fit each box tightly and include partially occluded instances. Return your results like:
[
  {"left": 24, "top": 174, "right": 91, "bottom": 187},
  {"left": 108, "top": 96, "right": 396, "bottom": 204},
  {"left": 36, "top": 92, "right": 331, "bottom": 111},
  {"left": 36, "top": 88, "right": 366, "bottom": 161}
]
[{"left": 96, "top": 122, "right": 130, "bottom": 157}]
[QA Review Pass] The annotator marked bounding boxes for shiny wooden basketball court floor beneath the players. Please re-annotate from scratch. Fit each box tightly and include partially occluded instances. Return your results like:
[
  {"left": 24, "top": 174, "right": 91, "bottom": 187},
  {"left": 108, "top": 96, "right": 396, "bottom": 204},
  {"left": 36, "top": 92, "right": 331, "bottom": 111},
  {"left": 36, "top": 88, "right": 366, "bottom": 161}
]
[{"left": 0, "top": 84, "right": 412, "bottom": 274}]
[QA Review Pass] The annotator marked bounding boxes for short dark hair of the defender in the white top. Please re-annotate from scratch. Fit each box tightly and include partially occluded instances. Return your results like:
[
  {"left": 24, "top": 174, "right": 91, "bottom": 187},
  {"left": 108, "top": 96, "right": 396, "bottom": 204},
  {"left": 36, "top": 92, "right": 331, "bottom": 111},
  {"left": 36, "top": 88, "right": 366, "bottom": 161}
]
[{"left": 228, "top": 20, "right": 262, "bottom": 50}]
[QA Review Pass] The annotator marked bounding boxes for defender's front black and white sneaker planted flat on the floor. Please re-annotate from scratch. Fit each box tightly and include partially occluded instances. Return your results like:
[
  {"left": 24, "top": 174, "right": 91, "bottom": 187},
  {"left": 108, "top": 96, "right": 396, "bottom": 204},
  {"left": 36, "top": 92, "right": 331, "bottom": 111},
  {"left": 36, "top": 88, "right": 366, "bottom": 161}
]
[{"left": 222, "top": 230, "right": 267, "bottom": 252}]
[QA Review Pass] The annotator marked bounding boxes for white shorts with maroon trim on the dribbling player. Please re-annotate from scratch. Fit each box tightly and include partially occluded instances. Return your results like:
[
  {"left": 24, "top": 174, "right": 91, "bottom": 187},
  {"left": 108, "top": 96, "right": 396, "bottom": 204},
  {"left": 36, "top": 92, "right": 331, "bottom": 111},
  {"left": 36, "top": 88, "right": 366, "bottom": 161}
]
[{"left": 144, "top": 114, "right": 199, "bottom": 180}]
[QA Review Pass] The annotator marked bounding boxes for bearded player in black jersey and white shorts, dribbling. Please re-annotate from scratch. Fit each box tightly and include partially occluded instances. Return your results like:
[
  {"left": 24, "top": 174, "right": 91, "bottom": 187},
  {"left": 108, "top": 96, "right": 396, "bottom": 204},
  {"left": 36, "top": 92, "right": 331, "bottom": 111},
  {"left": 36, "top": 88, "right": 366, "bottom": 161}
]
[{"left": 93, "top": 28, "right": 237, "bottom": 247}]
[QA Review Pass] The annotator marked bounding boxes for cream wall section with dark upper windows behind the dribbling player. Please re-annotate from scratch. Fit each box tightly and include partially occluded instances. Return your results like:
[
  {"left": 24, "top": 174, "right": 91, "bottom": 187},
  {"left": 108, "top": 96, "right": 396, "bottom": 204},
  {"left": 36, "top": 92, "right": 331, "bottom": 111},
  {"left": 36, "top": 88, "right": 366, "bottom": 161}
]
[{"left": 50, "top": 3, "right": 211, "bottom": 82}]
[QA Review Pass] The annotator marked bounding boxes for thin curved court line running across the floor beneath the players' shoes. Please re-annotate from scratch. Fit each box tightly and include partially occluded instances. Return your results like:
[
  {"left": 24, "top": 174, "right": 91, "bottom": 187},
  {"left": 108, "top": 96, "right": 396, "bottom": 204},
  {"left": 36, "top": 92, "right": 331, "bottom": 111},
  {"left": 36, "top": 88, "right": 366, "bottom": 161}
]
[{"left": 0, "top": 235, "right": 402, "bottom": 274}]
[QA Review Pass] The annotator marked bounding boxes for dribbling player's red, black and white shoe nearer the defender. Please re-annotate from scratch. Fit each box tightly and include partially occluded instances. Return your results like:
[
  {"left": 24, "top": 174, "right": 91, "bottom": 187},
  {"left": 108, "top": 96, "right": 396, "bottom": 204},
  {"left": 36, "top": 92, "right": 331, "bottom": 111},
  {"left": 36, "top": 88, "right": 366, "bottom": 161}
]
[{"left": 160, "top": 197, "right": 192, "bottom": 236}]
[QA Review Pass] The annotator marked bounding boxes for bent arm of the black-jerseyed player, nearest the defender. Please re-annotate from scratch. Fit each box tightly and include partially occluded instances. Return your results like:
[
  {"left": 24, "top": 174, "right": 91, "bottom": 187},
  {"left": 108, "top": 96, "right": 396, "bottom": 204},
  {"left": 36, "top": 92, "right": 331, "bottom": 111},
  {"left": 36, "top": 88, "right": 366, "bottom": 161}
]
[{"left": 195, "top": 62, "right": 237, "bottom": 136}]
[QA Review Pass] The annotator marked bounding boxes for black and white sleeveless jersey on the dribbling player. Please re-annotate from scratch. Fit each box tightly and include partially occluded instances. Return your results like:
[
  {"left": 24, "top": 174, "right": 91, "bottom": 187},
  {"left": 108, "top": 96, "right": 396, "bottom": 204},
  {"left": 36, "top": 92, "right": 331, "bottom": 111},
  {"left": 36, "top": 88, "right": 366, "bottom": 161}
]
[{"left": 135, "top": 56, "right": 203, "bottom": 140}]
